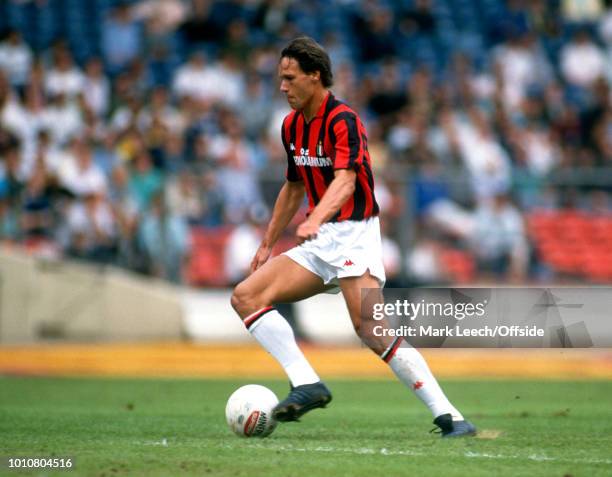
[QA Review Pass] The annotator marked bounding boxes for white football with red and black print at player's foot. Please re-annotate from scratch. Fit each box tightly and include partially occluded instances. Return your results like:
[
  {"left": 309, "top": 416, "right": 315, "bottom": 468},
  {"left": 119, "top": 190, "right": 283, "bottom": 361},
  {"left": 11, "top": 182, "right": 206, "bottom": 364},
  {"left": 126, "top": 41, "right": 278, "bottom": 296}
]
[{"left": 225, "top": 384, "right": 278, "bottom": 437}]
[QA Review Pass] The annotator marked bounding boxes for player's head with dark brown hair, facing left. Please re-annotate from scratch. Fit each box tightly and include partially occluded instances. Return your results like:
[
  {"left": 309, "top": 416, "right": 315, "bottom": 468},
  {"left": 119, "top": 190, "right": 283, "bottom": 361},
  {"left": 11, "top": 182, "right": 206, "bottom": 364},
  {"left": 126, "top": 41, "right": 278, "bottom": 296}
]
[{"left": 278, "top": 36, "right": 333, "bottom": 110}]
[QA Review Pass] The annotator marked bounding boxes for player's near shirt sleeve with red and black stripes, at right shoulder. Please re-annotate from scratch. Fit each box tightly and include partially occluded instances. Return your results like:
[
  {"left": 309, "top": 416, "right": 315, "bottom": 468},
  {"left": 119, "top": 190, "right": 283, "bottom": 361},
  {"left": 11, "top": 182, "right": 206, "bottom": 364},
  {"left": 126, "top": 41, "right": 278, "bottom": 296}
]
[{"left": 329, "top": 112, "right": 363, "bottom": 170}]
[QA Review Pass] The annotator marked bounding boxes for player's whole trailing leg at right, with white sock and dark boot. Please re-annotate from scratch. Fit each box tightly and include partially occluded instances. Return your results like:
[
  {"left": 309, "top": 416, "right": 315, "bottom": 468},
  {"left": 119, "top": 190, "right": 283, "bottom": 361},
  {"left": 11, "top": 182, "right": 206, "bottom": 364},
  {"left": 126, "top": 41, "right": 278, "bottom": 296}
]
[{"left": 339, "top": 271, "right": 475, "bottom": 436}]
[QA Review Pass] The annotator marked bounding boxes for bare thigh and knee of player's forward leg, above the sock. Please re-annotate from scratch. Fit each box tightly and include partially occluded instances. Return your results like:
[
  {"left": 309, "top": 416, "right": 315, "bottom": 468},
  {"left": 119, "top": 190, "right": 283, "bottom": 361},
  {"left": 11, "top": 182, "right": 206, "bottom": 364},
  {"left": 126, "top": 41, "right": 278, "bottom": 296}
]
[{"left": 232, "top": 255, "right": 328, "bottom": 318}]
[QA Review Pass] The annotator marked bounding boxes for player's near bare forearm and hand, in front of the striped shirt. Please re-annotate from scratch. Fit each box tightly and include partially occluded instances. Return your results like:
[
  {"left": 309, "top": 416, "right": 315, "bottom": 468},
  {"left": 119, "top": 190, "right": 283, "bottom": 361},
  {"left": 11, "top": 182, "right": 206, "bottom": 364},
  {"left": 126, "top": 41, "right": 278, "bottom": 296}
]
[{"left": 296, "top": 169, "right": 357, "bottom": 242}]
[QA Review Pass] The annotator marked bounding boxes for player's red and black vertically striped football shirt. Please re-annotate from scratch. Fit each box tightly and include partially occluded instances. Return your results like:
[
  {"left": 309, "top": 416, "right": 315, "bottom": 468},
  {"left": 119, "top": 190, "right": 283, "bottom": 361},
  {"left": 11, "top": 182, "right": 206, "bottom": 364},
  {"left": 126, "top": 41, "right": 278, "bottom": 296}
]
[{"left": 282, "top": 93, "right": 379, "bottom": 222}]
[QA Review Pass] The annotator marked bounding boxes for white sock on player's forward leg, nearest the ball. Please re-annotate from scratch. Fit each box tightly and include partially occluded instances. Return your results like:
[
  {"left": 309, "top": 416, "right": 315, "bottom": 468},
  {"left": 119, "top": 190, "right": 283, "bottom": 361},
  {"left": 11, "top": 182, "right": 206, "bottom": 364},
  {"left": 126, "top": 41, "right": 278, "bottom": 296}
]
[{"left": 244, "top": 306, "right": 321, "bottom": 386}]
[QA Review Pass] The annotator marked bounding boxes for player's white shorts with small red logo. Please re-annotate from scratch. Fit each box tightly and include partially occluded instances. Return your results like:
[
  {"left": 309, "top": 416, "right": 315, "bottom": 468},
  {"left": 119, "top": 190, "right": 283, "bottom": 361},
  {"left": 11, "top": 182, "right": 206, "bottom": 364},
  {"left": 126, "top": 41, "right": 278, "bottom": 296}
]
[{"left": 284, "top": 217, "right": 386, "bottom": 293}]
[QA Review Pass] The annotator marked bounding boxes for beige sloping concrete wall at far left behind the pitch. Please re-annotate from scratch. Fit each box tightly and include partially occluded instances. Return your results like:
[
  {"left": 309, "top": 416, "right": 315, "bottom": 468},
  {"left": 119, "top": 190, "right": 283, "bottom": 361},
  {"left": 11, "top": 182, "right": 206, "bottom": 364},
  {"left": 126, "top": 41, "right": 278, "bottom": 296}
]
[{"left": 0, "top": 249, "right": 183, "bottom": 344}]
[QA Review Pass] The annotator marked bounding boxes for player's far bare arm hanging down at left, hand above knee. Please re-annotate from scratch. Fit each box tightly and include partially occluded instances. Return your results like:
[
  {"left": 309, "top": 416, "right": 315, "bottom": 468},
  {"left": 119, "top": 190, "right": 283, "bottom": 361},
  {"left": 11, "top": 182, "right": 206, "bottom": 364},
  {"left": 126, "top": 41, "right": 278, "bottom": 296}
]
[{"left": 251, "top": 181, "right": 305, "bottom": 273}]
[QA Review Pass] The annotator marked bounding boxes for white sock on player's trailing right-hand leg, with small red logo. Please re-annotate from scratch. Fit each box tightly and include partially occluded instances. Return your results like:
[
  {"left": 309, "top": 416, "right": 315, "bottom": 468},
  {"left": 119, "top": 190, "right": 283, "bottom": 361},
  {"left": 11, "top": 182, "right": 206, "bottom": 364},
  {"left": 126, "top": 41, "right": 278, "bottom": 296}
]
[{"left": 381, "top": 340, "right": 463, "bottom": 421}]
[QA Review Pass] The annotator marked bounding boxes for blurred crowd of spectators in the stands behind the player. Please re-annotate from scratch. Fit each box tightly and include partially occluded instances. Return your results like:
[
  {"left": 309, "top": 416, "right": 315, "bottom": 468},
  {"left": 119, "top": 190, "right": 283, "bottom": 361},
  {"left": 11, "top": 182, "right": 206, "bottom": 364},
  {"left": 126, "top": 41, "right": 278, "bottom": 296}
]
[{"left": 0, "top": 0, "right": 612, "bottom": 284}]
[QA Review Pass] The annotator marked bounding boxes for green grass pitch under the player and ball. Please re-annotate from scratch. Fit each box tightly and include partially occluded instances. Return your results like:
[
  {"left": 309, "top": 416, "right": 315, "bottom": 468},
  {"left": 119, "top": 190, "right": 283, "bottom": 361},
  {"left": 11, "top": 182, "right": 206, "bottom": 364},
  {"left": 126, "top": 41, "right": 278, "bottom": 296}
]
[{"left": 0, "top": 377, "right": 612, "bottom": 477}]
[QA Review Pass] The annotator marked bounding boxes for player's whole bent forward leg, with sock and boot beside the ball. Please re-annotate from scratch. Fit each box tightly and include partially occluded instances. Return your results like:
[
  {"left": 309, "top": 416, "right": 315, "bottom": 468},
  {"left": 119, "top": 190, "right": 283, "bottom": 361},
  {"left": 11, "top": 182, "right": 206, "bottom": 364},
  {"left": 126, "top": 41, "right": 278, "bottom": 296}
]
[{"left": 231, "top": 255, "right": 331, "bottom": 421}]
